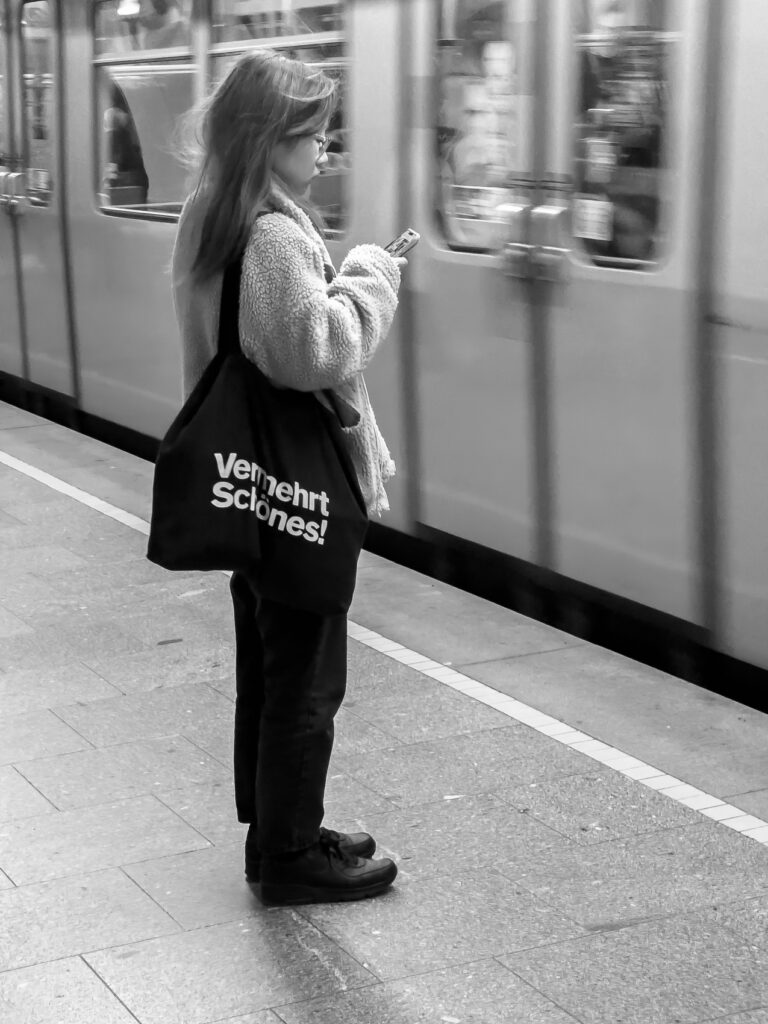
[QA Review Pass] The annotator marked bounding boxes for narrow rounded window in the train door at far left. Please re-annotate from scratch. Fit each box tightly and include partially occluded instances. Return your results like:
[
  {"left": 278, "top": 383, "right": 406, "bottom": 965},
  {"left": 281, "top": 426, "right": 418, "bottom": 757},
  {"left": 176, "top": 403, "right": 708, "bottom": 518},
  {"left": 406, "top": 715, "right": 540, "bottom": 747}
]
[{"left": 22, "top": 0, "right": 54, "bottom": 206}]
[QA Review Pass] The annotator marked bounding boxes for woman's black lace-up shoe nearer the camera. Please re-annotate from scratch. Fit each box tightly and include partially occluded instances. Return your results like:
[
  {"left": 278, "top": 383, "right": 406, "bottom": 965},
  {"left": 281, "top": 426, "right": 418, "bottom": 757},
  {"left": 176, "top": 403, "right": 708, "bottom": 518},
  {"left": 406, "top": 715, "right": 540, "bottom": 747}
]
[{"left": 261, "top": 835, "right": 397, "bottom": 906}]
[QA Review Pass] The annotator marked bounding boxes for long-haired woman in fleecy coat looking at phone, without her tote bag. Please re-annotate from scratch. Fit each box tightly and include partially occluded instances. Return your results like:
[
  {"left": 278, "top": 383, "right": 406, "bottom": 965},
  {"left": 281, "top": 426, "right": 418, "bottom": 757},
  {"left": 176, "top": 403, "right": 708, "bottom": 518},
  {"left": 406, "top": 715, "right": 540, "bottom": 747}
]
[{"left": 173, "top": 50, "right": 406, "bottom": 903}]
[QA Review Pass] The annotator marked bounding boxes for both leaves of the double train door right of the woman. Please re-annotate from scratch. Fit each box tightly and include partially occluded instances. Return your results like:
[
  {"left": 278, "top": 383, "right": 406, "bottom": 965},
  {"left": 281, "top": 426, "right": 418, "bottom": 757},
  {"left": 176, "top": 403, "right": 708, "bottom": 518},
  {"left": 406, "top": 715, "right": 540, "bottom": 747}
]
[{"left": 414, "top": 0, "right": 706, "bottom": 620}]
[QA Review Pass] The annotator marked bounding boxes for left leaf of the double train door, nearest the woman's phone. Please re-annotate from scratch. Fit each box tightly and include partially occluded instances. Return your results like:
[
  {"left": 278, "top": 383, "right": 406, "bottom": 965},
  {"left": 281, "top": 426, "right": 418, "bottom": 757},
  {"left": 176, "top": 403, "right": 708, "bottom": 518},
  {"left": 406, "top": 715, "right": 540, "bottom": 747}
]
[{"left": 403, "top": 0, "right": 540, "bottom": 561}]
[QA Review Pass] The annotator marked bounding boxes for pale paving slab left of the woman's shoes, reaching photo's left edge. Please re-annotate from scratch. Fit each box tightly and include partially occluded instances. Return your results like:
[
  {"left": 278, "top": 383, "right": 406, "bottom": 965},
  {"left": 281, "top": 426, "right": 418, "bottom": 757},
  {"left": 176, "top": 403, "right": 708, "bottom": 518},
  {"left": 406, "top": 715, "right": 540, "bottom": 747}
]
[{"left": 0, "top": 797, "right": 209, "bottom": 886}]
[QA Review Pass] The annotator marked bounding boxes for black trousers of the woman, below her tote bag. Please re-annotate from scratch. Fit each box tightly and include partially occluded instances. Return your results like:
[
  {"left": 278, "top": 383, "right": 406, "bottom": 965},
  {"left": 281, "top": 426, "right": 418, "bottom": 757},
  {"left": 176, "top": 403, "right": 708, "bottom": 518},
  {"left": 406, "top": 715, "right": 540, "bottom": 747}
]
[{"left": 229, "top": 572, "right": 347, "bottom": 854}]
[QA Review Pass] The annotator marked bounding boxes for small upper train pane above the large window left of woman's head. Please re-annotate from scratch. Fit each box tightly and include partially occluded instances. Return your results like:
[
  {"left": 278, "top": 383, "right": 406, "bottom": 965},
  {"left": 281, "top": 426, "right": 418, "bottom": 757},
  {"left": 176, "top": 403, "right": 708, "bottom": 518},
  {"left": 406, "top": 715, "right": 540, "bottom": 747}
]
[{"left": 94, "top": 0, "right": 191, "bottom": 54}]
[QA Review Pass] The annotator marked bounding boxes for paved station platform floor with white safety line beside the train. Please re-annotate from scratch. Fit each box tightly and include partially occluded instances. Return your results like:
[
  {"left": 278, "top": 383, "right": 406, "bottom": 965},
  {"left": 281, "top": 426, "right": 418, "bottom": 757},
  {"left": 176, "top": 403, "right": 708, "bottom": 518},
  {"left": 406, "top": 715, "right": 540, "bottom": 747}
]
[{"left": 0, "top": 404, "right": 768, "bottom": 1024}]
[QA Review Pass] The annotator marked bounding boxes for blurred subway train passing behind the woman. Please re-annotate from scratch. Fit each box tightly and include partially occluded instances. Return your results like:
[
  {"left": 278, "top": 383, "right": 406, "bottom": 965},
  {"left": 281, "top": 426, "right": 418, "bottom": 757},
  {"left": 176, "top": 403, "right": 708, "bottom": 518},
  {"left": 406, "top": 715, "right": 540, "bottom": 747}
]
[{"left": 0, "top": 0, "right": 768, "bottom": 691}]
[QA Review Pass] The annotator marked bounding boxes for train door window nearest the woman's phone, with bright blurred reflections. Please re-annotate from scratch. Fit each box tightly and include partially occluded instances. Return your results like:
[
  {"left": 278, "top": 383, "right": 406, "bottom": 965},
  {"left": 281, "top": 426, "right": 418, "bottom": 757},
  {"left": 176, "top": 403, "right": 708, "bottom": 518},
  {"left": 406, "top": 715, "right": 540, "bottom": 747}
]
[{"left": 435, "top": 0, "right": 532, "bottom": 251}]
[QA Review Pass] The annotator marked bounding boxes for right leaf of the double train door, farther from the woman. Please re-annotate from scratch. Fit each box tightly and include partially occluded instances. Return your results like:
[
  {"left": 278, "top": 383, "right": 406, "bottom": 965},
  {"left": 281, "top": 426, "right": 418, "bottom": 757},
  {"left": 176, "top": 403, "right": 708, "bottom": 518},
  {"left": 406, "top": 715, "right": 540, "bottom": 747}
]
[{"left": 548, "top": 0, "right": 714, "bottom": 621}]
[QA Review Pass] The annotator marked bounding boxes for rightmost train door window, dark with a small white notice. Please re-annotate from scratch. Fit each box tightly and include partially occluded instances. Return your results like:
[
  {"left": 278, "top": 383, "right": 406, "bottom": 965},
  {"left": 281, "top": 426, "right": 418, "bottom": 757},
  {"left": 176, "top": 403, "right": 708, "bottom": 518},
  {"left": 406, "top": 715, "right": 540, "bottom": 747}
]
[{"left": 573, "top": 0, "right": 674, "bottom": 269}]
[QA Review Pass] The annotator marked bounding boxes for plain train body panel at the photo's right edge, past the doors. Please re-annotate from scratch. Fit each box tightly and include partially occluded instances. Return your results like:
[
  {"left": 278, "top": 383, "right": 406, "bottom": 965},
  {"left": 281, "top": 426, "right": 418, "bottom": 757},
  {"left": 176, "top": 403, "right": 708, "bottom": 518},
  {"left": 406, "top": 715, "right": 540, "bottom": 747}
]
[{"left": 711, "top": 0, "right": 768, "bottom": 666}]
